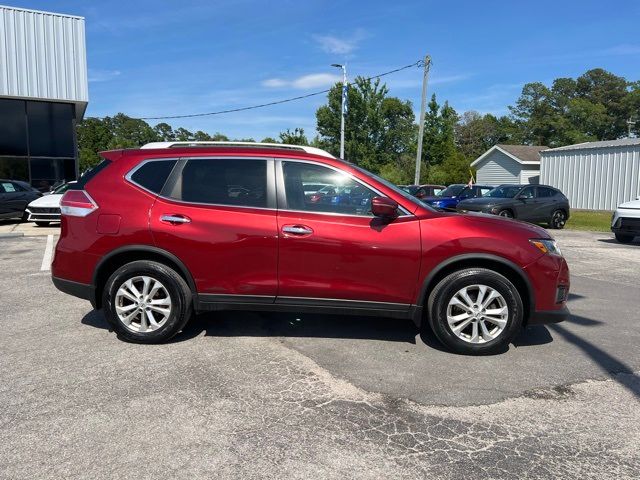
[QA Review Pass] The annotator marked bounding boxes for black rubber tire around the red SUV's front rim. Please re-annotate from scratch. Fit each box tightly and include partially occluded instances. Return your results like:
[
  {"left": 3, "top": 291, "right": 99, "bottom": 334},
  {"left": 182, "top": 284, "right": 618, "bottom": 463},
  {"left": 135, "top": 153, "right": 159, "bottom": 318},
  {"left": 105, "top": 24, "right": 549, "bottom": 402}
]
[{"left": 427, "top": 268, "right": 523, "bottom": 355}]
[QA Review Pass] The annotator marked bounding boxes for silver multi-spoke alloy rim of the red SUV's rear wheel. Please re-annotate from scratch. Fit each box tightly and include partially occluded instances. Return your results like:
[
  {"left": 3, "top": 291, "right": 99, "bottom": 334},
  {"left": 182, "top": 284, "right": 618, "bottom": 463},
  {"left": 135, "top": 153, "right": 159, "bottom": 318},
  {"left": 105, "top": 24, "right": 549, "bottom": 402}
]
[{"left": 115, "top": 276, "right": 172, "bottom": 333}]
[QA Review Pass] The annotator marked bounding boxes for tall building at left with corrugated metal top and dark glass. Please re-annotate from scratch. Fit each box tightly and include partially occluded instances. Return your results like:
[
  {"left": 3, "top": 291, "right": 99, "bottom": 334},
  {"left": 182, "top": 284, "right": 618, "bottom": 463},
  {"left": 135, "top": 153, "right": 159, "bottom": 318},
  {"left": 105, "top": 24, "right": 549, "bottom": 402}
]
[{"left": 0, "top": 6, "right": 89, "bottom": 190}]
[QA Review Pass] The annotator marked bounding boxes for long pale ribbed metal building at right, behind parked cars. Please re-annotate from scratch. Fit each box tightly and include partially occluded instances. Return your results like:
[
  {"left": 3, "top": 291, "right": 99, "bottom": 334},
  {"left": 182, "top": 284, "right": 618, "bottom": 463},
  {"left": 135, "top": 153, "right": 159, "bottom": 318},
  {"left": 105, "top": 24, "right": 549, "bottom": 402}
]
[{"left": 540, "top": 138, "right": 640, "bottom": 210}]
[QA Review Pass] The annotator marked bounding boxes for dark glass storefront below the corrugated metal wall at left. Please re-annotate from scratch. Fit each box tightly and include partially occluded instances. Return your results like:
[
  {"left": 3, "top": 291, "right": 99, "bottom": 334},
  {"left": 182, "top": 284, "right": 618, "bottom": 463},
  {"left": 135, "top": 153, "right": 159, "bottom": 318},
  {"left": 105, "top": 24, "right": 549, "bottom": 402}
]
[{"left": 0, "top": 99, "right": 76, "bottom": 191}]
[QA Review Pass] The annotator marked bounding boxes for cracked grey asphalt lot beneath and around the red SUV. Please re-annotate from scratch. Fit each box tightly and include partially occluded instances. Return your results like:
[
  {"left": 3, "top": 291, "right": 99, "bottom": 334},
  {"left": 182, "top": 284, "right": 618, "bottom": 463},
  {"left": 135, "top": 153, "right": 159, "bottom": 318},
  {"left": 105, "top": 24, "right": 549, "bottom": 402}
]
[{"left": 0, "top": 230, "right": 640, "bottom": 479}]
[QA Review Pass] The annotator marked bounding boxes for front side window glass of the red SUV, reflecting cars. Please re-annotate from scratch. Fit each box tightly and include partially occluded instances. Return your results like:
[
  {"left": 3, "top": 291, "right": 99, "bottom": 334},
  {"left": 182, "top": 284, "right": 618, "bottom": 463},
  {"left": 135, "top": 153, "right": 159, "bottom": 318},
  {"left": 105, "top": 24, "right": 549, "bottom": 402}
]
[{"left": 282, "top": 162, "right": 377, "bottom": 216}]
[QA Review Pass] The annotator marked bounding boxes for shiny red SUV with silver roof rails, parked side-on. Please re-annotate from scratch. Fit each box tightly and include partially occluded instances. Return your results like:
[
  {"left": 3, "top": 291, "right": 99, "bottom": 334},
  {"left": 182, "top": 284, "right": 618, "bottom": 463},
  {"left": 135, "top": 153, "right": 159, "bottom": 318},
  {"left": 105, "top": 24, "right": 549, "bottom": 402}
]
[{"left": 52, "top": 142, "right": 569, "bottom": 354}]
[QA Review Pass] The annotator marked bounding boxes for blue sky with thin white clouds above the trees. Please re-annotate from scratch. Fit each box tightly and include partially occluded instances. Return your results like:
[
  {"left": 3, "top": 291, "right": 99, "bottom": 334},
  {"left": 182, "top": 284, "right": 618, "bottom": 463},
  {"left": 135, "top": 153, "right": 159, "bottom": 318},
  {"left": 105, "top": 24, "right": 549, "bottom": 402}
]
[{"left": 5, "top": 0, "right": 640, "bottom": 140}]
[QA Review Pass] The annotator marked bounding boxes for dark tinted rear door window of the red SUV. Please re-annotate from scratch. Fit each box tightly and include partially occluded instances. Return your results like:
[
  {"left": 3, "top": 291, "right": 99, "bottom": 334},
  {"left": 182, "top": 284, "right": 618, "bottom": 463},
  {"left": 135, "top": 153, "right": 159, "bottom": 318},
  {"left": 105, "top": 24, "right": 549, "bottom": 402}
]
[{"left": 172, "top": 158, "right": 267, "bottom": 208}]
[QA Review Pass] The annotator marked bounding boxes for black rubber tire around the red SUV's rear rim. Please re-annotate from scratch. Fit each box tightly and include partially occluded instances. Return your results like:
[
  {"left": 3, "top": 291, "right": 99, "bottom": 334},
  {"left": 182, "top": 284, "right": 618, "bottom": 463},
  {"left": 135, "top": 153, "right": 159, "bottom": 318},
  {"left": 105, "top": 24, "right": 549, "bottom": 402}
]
[{"left": 102, "top": 260, "right": 192, "bottom": 343}]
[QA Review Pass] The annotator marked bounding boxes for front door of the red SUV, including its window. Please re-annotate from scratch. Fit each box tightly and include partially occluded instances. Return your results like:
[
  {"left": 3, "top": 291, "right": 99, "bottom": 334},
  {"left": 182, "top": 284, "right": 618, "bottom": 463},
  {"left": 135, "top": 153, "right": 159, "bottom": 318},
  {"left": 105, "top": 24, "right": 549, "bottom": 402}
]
[{"left": 276, "top": 160, "right": 420, "bottom": 309}]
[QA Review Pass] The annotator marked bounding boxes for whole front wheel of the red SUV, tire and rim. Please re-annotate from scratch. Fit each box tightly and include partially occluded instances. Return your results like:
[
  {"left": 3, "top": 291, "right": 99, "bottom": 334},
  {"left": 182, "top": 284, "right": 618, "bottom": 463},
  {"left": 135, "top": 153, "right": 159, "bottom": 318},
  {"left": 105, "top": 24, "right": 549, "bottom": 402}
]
[{"left": 427, "top": 268, "right": 523, "bottom": 355}]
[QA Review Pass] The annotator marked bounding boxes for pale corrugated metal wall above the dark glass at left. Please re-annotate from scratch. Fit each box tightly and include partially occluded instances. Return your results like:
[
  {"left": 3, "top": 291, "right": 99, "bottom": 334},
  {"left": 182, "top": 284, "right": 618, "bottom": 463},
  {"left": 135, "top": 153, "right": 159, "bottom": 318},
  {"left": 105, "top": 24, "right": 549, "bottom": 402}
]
[{"left": 0, "top": 6, "right": 89, "bottom": 103}]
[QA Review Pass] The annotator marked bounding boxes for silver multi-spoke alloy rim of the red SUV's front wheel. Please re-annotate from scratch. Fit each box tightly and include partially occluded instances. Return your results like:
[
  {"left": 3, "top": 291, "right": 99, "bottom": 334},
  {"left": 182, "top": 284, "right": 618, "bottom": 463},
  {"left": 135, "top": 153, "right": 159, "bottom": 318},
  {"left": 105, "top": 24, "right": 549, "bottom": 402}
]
[{"left": 447, "top": 285, "right": 509, "bottom": 343}]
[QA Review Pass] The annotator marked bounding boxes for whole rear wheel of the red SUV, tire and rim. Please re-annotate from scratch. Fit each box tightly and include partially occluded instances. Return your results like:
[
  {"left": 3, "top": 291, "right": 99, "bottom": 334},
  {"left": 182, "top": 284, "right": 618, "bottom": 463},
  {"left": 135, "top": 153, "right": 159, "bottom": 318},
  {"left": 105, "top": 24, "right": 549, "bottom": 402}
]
[{"left": 102, "top": 261, "right": 191, "bottom": 343}]
